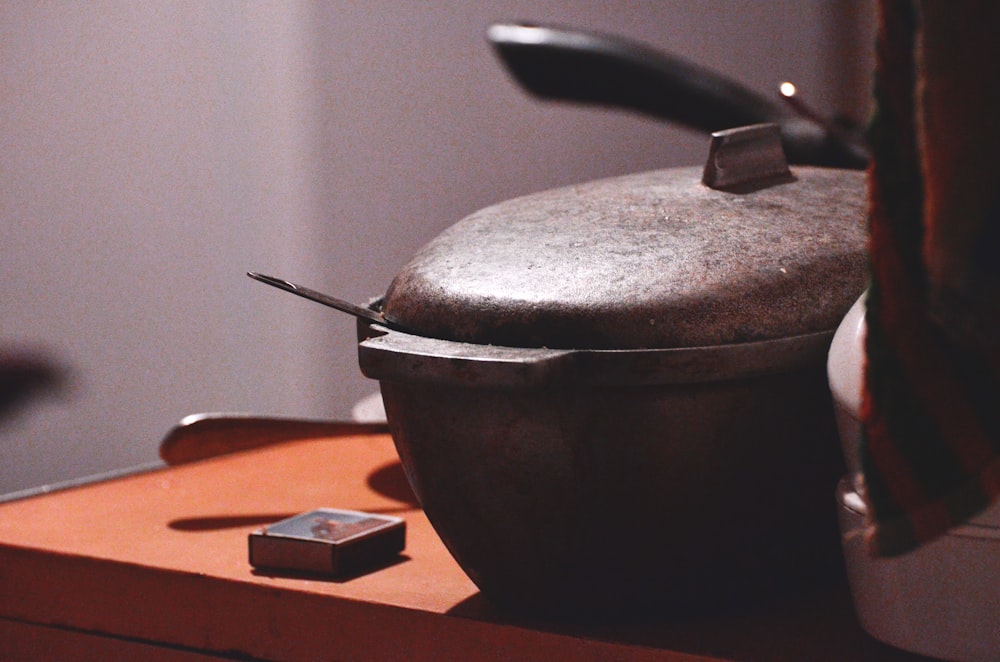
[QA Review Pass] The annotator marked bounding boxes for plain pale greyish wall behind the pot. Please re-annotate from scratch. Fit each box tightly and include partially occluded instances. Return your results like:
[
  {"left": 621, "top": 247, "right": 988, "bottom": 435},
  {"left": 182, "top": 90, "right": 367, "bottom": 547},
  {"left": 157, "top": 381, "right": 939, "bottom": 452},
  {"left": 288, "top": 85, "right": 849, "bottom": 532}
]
[{"left": 0, "top": 0, "right": 872, "bottom": 493}]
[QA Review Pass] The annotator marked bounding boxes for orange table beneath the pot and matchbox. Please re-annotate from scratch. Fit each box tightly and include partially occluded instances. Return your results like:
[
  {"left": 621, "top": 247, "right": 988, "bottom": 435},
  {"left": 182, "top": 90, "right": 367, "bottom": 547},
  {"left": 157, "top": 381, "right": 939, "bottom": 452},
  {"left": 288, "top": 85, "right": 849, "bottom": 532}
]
[{"left": 0, "top": 435, "right": 917, "bottom": 662}]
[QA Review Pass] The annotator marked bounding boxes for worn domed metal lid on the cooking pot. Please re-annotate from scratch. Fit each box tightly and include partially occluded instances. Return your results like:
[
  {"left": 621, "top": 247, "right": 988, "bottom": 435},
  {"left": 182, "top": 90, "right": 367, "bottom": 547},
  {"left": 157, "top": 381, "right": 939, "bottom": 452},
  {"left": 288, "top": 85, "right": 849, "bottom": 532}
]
[{"left": 382, "top": 127, "right": 867, "bottom": 349}]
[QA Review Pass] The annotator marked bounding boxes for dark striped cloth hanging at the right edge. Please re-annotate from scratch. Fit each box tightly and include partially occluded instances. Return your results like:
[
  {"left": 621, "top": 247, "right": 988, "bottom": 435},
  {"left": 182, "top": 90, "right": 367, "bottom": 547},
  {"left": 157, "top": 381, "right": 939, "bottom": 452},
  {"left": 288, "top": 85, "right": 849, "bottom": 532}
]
[{"left": 859, "top": 0, "right": 1000, "bottom": 556}]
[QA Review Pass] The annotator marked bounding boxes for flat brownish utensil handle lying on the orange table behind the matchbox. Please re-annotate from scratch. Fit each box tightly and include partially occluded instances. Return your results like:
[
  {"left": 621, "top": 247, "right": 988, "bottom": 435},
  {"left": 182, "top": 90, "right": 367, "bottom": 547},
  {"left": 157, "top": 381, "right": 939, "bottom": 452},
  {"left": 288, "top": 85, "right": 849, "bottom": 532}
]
[{"left": 160, "top": 414, "right": 389, "bottom": 465}]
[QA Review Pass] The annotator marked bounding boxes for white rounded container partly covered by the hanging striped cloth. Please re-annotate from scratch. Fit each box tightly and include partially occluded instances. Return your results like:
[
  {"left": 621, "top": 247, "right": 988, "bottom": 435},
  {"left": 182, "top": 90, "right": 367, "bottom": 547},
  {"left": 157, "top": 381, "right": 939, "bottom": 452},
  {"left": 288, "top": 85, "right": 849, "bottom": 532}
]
[{"left": 827, "top": 295, "right": 1000, "bottom": 661}]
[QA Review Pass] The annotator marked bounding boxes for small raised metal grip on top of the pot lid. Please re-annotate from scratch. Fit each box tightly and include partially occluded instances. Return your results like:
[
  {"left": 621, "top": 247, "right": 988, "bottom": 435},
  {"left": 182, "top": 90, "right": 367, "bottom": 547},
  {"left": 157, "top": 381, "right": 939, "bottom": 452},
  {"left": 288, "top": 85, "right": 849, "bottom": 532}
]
[{"left": 701, "top": 124, "right": 792, "bottom": 190}]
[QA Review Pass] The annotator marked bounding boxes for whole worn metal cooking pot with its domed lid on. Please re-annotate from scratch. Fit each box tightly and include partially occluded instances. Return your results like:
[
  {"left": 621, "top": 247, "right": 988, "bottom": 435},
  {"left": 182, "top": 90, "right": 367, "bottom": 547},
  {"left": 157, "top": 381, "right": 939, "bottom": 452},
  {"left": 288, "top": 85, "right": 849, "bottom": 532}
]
[{"left": 359, "top": 127, "right": 866, "bottom": 614}]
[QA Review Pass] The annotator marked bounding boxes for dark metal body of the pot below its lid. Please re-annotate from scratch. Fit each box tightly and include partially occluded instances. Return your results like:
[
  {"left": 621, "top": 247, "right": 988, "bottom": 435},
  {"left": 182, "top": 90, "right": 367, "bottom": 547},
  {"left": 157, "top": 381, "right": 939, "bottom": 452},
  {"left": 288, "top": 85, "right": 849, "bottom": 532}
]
[{"left": 359, "top": 329, "right": 844, "bottom": 615}]
